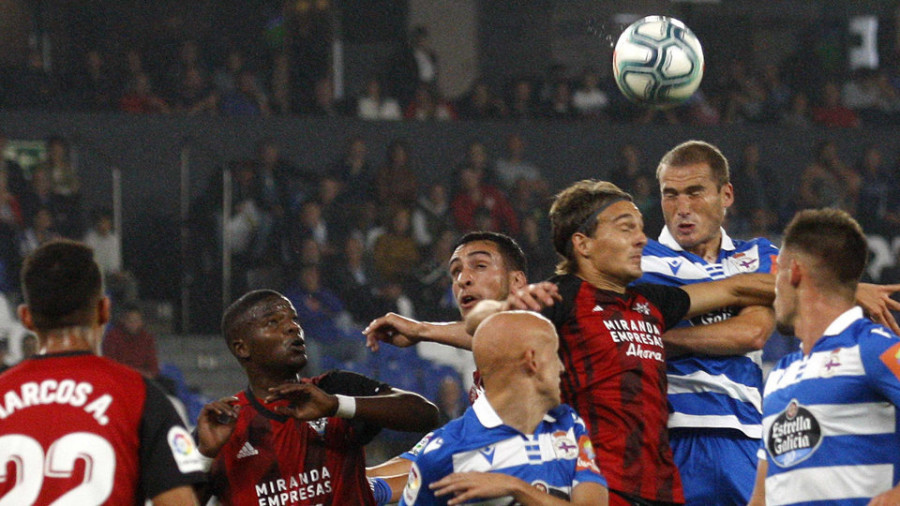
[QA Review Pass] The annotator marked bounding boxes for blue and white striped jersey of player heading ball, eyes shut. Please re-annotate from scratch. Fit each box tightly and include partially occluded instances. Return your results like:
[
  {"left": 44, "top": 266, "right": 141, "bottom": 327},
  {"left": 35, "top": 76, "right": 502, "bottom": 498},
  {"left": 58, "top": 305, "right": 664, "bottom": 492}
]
[{"left": 634, "top": 227, "right": 778, "bottom": 438}]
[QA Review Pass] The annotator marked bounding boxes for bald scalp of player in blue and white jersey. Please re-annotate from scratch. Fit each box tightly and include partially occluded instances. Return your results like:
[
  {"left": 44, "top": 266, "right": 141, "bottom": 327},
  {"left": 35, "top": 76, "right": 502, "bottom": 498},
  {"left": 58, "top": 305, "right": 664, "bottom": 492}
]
[{"left": 472, "top": 311, "right": 559, "bottom": 377}]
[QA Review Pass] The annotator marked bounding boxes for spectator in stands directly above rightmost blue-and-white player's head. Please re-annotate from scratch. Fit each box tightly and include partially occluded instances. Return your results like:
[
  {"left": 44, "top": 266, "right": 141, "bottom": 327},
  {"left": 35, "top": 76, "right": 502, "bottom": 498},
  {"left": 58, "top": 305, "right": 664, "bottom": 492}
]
[{"left": 800, "top": 141, "right": 861, "bottom": 213}]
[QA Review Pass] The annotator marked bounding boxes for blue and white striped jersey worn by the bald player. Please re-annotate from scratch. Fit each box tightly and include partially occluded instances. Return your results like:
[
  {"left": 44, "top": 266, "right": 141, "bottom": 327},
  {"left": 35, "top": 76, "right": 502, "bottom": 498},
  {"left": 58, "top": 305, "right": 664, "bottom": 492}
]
[{"left": 400, "top": 396, "right": 606, "bottom": 506}]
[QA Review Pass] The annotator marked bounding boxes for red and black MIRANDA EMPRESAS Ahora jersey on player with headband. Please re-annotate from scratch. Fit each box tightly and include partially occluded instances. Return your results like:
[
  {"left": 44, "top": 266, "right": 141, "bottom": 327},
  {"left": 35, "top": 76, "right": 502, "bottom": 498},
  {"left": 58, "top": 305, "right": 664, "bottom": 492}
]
[{"left": 543, "top": 275, "right": 690, "bottom": 502}]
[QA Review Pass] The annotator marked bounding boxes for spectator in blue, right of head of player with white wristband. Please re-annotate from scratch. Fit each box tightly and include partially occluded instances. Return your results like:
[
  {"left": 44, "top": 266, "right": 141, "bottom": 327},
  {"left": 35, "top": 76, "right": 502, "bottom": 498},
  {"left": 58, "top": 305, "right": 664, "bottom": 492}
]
[{"left": 284, "top": 265, "right": 365, "bottom": 371}]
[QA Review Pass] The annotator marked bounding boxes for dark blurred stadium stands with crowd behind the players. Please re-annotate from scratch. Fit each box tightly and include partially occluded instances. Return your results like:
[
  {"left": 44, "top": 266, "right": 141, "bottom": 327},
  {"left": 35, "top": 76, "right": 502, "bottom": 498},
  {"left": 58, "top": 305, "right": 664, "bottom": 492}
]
[{"left": 0, "top": 0, "right": 900, "bottom": 460}]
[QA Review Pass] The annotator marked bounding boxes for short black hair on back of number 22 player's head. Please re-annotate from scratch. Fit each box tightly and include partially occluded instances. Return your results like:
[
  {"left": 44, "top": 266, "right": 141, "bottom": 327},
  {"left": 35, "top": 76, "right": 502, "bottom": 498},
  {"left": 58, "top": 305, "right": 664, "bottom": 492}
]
[{"left": 21, "top": 239, "right": 103, "bottom": 332}]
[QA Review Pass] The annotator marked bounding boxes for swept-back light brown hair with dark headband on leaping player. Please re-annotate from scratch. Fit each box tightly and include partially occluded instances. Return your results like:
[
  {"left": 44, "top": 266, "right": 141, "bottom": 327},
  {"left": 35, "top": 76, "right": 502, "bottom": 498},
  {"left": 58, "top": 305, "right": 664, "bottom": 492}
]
[{"left": 550, "top": 179, "right": 632, "bottom": 274}]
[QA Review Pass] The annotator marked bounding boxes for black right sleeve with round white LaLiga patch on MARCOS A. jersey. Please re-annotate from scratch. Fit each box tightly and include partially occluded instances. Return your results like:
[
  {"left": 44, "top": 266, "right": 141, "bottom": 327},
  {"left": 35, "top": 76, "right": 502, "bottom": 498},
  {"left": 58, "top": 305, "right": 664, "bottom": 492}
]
[{"left": 140, "top": 379, "right": 205, "bottom": 499}]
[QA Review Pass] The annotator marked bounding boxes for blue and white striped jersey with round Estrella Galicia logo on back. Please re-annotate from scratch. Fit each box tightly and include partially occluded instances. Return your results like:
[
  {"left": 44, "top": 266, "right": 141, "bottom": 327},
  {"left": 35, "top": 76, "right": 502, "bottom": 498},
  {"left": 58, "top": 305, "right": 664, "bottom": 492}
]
[{"left": 759, "top": 307, "right": 900, "bottom": 506}]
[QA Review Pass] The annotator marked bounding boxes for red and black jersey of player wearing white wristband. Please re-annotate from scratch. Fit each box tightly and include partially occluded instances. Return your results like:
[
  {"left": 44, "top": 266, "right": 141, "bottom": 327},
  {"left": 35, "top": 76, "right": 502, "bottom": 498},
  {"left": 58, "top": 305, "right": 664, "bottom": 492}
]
[{"left": 209, "top": 371, "right": 390, "bottom": 506}]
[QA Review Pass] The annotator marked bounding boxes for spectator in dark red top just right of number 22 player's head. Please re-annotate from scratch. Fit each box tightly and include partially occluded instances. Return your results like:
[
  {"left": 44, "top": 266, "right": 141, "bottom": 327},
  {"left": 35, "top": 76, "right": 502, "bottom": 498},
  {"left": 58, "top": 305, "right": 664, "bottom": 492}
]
[{"left": 103, "top": 303, "right": 159, "bottom": 378}]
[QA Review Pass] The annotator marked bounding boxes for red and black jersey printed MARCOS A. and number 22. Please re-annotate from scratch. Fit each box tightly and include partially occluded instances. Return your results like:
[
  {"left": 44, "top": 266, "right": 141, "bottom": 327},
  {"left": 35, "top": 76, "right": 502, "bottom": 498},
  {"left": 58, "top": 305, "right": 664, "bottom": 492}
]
[{"left": 0, "top": 352, "right": 204, "bottom": 504}]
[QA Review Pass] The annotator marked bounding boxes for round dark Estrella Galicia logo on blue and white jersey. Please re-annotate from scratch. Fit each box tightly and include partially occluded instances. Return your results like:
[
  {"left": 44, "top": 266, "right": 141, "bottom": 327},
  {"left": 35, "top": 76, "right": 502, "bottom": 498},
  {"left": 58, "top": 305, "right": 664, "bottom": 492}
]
[{"left": 766, "top": 399, "right": 822, "bottom": 467}]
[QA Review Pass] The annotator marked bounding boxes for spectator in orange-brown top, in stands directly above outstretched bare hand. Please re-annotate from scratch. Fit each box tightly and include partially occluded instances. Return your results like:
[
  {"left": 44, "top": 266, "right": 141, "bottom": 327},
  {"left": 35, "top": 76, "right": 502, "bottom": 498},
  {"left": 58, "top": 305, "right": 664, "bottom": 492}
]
[{"left": 372, "top": 206, "right": 421, "bottom": 282}]
